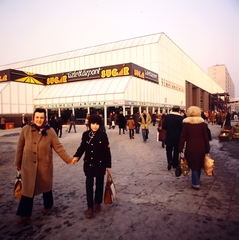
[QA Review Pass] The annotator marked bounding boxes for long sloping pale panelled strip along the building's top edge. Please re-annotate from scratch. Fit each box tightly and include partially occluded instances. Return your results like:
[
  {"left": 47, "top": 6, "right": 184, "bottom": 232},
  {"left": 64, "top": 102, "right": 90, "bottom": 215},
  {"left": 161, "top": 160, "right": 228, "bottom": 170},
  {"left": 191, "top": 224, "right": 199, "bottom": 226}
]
[{"left": 0, "top": 33, "right": 162, "bottom": 70}]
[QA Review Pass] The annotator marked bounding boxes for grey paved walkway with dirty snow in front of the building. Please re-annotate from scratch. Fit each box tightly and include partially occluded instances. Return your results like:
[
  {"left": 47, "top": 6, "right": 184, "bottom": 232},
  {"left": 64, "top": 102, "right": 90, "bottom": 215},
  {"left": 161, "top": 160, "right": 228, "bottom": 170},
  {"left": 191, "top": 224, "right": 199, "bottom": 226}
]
[{"left": 0, "top": 122, "right": 239, "bottom": 240}]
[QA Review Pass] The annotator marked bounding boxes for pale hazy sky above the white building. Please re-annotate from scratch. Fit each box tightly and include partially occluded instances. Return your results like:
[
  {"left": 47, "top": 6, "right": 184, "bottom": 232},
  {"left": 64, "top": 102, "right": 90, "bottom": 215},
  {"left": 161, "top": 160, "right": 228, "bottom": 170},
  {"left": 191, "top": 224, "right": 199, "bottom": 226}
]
[{"left": 0, "top": 0, "right": 239, "bottom": 98}]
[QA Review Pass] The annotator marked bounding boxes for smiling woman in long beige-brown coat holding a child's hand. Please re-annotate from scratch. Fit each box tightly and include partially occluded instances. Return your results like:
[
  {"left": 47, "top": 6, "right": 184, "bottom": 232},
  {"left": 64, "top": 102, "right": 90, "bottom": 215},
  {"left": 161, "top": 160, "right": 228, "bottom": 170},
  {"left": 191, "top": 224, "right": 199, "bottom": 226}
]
[{"left": 14, "top": 108, "right": 75, "bottom": 225}]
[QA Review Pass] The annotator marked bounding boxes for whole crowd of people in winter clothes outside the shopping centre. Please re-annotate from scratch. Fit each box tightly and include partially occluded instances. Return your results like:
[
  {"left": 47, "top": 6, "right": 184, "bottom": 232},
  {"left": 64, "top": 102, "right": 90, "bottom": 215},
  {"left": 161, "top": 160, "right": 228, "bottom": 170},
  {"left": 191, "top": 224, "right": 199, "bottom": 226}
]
[{"left": 11, "top": 106, "right": 235, "bottom": 225}]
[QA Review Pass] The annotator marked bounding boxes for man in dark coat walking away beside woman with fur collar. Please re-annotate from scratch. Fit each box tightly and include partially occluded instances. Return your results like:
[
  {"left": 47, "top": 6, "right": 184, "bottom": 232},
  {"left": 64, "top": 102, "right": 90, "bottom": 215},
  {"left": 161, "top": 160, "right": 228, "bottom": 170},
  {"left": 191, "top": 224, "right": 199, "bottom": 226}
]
[{"left": 163, "top": 106, "right": 183, "bottom": 170}]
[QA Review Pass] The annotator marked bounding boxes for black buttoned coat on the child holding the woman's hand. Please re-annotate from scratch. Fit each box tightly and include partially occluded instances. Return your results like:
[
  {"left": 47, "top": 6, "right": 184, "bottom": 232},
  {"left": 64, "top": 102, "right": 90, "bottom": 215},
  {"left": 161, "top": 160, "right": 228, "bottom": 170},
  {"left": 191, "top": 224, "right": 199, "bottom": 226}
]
[{"left": 74, "top": 130, "right": 111, "bottom": 177}]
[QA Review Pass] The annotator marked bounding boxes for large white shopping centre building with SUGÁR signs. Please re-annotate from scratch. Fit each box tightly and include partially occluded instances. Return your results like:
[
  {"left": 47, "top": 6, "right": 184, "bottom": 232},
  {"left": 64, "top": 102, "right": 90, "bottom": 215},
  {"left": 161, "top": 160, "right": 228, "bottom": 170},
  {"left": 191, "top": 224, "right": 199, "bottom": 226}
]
[{"left": 0, "top": 33, "right": 224, "bottom": 126}]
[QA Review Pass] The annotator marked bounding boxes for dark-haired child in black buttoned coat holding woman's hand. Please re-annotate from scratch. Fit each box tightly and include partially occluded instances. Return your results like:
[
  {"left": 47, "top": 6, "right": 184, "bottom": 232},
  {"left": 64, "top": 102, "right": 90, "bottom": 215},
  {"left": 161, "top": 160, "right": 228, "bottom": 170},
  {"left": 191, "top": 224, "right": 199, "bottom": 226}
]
[{"left": 74, "top": 115, "right": 111, "bottom": 218}]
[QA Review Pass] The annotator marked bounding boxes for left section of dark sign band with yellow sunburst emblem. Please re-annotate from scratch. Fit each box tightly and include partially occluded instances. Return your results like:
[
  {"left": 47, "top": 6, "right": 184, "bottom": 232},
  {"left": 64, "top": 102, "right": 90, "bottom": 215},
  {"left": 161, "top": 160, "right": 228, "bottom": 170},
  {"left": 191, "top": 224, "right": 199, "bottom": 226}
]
[{"left": 0, "top": 69, "right": 47, "bottom": 85}]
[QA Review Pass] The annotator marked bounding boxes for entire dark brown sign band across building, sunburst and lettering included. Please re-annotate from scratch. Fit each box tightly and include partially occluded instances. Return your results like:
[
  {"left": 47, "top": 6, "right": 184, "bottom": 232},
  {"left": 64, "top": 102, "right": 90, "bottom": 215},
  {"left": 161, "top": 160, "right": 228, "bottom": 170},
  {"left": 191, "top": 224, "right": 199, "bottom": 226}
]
[{"left": 0, "top": 63, "right": 159, "bottom": 85}]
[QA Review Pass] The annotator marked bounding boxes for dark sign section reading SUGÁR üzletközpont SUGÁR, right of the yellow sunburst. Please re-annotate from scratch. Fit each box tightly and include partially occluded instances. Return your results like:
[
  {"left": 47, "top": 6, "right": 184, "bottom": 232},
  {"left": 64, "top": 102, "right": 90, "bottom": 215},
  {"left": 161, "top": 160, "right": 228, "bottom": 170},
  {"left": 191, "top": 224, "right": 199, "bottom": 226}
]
[{"left": 46, "top": 63, "right": 158, "bottom": 85}]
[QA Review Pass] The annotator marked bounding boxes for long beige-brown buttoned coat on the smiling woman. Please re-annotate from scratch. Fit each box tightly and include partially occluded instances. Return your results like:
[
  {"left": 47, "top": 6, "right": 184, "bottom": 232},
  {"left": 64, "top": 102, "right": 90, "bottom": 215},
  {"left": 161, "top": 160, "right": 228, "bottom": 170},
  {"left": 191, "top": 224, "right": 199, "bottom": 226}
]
[{"left": 14, "top": 125, "right": 73, "bottom": 198}]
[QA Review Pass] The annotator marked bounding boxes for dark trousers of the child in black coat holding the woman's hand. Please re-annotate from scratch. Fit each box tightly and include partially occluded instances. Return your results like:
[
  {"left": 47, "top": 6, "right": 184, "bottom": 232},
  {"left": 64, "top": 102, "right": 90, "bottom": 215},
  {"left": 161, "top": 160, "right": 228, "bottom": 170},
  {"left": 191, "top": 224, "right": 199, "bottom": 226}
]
[{"left": 86, "top": 176, "right": 104, "bottom": 208}]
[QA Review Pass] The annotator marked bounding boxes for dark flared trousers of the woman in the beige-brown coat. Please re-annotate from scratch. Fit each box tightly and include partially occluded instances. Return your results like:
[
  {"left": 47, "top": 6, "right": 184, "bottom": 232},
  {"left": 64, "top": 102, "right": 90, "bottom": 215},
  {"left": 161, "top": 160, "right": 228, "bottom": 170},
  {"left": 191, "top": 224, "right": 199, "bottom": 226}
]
[{"left": 17, "top": 191, "right": 53, "bottom": 217}]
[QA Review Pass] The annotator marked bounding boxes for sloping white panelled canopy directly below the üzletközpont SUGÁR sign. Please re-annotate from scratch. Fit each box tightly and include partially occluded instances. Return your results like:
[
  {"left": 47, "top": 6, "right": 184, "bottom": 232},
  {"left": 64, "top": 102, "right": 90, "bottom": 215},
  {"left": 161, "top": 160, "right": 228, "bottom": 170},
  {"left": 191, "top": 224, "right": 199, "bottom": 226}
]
[{"left": 34, "top": 76, "right": 133, "bottom": 105}]
